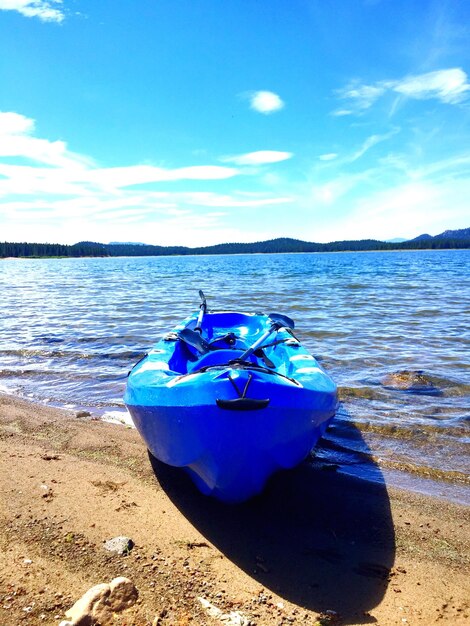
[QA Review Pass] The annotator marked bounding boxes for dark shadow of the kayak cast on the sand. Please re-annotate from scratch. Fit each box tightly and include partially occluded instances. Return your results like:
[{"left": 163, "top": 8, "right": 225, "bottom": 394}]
[{"left": 149, "top": 412, "right": 395, "bottom": 624}]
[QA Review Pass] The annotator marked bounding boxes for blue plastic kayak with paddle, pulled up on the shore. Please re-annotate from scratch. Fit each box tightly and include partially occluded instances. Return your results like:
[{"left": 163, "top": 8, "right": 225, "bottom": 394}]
[{"left": 124, "top": 292, "right": 338, "bottom": 502}]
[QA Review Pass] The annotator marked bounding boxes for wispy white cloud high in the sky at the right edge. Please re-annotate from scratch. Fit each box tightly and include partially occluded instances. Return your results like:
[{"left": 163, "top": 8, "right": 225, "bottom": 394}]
[{"left": 333, "top": 67, "right": 470, "bottom": 116}]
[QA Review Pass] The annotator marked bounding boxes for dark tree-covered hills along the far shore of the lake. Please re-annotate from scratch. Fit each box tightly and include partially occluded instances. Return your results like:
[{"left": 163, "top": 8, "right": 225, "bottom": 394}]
[{"left": 0, "top": 228, "right": 470, "bottom": 258}]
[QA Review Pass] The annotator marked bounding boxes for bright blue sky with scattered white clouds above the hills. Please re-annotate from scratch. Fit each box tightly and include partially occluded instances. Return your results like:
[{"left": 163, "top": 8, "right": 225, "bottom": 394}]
[{"left": 0, "top": 0, "right": 470, "bottom": 246}]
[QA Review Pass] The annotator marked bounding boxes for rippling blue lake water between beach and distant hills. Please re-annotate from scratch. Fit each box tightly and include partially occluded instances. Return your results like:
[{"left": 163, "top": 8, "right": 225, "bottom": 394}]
[{"left": 0, "top": 250, "right": 470, "bottom": 502}]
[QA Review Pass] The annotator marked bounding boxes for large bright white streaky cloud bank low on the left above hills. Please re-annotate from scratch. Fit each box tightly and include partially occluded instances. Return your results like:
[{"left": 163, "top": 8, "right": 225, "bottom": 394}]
[{"left": 0, "top": 112, "right": 292, "bottom": 245}]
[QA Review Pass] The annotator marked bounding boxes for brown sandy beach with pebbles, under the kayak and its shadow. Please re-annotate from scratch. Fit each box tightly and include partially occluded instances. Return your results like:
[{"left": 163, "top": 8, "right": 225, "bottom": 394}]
[{"left": 0, "top": 395, "right": 470, "bottom": 626}]
